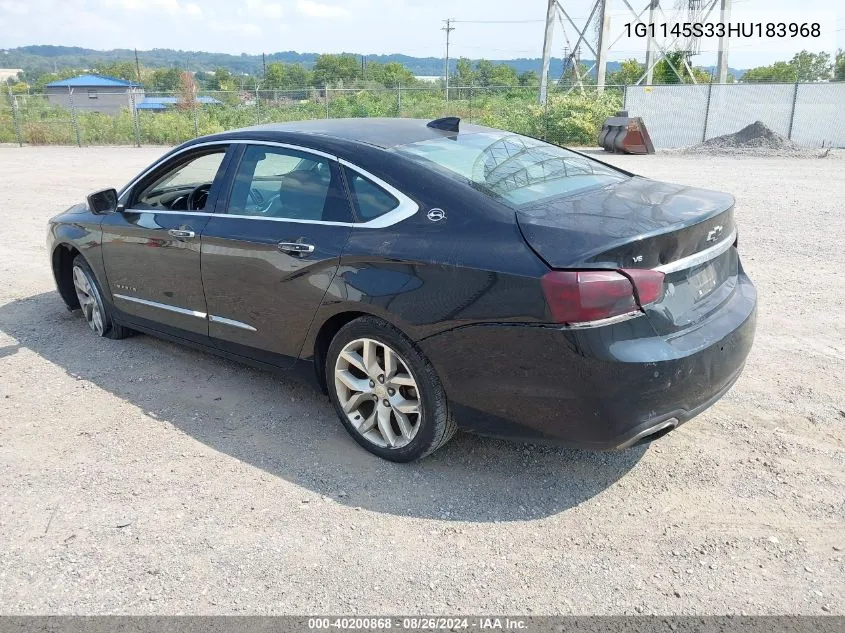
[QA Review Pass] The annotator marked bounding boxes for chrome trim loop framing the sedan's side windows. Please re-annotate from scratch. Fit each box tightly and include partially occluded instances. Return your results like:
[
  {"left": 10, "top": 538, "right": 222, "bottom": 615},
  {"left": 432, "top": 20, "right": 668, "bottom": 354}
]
[{"left": 118, "top": 139, "right": 419, "bottom": 229}]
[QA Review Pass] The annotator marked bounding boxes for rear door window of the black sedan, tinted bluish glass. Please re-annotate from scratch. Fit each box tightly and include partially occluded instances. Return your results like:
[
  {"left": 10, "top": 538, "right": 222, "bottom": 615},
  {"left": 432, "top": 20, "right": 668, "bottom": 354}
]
[{"left": 228, "top": 145, "right": 351, "bottom": 222}]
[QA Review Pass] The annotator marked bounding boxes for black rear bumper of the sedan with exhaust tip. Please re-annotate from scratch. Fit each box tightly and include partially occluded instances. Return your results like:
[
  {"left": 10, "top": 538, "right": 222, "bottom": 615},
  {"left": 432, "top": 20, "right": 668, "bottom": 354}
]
[{"left": 419, "top": 273, "right": 757, "bottom": 450}]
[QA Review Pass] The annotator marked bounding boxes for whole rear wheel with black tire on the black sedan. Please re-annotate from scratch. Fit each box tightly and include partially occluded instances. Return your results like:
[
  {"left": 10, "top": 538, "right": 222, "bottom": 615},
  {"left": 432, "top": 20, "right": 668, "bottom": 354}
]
[{"left": 325, "top": 316, "right": 457, "bottom": 462}]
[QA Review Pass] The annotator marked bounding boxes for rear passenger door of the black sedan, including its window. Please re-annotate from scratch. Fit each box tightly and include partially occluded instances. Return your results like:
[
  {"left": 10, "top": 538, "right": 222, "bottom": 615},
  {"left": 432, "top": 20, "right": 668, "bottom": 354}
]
[{"left": 202, "top": 143, "right": 352, "bottom": 367}]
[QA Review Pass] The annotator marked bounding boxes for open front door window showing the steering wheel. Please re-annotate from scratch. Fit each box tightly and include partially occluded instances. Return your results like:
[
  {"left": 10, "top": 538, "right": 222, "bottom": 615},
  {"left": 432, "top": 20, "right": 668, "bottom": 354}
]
[{"left": 132, "top": 147, "right": 226, "bottom": 211}]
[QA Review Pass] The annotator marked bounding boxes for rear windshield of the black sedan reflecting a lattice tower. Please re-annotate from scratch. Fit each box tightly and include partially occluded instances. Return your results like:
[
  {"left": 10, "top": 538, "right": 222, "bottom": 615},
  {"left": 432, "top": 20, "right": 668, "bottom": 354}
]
[{"left": 396, "top": 132, "right": 626, "bottom": 206}]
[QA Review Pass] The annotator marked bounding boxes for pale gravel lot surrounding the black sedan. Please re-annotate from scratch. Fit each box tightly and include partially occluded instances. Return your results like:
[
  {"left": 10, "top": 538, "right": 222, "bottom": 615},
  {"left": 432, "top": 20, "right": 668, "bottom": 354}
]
[{"left": 0, "top": 147, "right": 845, "bottom": 615}]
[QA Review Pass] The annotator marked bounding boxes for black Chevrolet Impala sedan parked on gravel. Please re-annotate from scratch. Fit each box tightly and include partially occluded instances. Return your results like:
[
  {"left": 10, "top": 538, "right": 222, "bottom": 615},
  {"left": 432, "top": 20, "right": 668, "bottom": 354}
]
[{"left": 49, "top": 118, "right": 757, "bottom": 461}]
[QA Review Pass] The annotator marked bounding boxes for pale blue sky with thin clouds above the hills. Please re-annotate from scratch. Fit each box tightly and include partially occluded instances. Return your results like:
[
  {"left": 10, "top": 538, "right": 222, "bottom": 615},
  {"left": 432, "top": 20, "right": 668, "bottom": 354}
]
[{"left": 0, "top": 0, "right": 845, "bottom": 68}]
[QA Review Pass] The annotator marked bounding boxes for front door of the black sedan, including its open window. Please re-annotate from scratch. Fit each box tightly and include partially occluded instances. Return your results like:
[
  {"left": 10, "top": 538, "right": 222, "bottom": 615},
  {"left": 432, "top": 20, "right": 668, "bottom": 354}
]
[{"left": 101, "top": 144, "right": 234, "bottom": 342}]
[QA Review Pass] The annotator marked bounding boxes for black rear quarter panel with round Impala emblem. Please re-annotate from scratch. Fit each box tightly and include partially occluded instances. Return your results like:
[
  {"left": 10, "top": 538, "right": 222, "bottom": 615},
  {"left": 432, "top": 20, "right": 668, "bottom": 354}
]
[{"left": 302, "top": 148, "right": 548, "bottom": 358}]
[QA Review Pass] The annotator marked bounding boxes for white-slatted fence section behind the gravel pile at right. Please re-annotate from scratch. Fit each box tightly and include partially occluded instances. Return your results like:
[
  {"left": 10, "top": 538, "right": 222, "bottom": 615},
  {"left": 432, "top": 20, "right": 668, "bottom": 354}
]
[{"left": 625, "top": 82, "right": 845, "bottom": 148}]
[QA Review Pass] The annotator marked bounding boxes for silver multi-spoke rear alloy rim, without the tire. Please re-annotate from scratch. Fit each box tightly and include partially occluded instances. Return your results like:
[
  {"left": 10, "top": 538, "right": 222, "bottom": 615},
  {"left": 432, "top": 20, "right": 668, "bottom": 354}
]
[{"left": 334, "top": 338, "right": 422, "bottom": 449}]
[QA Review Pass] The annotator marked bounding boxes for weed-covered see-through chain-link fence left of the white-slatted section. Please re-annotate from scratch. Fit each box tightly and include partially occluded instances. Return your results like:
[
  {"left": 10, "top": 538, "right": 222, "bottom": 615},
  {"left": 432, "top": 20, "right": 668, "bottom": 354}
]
[{"left": 0, "top": 86, "right": 624, "bottom": 146}]
